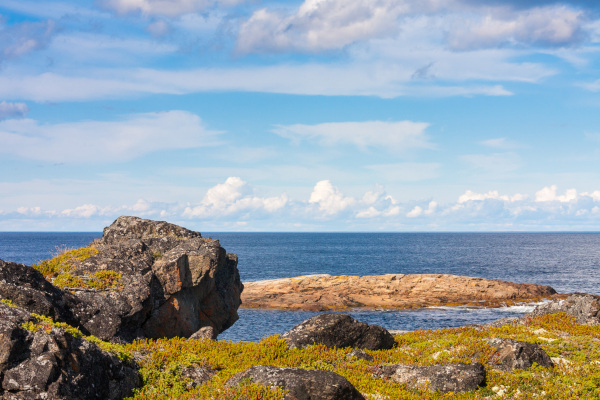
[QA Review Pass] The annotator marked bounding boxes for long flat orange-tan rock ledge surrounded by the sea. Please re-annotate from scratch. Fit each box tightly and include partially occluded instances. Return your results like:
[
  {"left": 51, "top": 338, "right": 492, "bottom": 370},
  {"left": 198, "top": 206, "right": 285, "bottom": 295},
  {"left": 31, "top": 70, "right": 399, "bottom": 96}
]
[{"left": 241, "top": 274, "right": 561, "bottom": 311}]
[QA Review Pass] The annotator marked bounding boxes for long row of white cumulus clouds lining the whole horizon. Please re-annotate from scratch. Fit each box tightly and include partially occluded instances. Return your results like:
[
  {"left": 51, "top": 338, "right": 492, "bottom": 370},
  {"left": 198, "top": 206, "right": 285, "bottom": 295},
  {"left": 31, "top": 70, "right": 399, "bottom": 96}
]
[{"left": 5, "top": 183, "right": 600, "bottom": 230}]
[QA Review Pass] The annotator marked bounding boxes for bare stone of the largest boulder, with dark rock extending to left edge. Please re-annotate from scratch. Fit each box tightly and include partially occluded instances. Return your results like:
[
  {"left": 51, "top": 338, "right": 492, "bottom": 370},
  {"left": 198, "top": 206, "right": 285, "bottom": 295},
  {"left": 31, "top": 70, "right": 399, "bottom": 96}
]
[{"left": 0, "top": 217, "right": 243, "bottom": 341}]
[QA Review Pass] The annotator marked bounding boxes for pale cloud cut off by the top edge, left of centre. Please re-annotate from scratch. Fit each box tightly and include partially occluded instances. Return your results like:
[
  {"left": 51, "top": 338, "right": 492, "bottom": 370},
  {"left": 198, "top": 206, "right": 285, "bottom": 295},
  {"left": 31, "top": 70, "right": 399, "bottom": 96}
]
[{"left": 100, "top": 0, "right": 244, "bottom": 17}]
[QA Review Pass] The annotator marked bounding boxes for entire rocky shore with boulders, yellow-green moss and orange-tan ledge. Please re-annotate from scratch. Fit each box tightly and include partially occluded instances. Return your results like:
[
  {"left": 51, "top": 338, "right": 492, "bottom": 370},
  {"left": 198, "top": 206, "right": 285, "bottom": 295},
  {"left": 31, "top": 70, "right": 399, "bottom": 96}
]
[{"left": 0, "top": 217, "right": 600, "bottom": 400}]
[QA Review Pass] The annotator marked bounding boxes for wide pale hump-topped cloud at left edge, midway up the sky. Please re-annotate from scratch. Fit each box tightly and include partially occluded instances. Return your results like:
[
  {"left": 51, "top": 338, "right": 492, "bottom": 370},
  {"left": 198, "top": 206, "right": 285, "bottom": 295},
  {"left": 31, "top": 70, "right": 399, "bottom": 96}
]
[{"left": 0, "top": 111, "right": 221, "bottom": 163}]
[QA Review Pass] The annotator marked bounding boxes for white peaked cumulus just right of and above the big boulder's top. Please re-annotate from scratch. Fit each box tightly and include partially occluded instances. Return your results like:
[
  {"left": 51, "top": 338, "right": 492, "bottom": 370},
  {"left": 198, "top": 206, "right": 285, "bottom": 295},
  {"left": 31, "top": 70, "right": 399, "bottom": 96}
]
[{"left": 183, "top": 177, "right": 288, "bottom": 218}]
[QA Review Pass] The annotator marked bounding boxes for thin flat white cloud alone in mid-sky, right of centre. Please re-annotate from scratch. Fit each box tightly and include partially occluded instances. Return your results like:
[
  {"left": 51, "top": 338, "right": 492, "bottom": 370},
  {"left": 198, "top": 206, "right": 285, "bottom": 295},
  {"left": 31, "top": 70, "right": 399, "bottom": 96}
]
[{"left": 273, "top": 121, "right": 432, "bottom": 151}]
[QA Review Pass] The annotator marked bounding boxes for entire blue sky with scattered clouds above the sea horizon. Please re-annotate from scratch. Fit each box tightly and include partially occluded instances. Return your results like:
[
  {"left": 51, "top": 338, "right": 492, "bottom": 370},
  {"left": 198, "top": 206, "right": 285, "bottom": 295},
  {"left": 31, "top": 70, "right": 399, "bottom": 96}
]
[{"left": 0, "top": 0, "right": 600, "bottom": 232}]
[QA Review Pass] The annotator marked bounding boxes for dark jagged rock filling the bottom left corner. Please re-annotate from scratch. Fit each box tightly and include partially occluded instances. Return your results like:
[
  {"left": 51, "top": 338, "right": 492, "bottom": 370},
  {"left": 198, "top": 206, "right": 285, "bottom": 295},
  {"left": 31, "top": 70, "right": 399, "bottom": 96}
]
[{"left": 0, "top": 303, "right": 141, "bottom": 400}]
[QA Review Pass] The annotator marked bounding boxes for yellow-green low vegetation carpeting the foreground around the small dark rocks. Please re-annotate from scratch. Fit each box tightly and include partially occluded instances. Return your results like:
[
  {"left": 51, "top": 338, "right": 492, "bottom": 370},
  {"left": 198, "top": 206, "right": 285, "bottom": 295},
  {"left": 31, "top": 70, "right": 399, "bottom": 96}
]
[{"left": 117, "top": 313, "right": 600, "bottom": 400}]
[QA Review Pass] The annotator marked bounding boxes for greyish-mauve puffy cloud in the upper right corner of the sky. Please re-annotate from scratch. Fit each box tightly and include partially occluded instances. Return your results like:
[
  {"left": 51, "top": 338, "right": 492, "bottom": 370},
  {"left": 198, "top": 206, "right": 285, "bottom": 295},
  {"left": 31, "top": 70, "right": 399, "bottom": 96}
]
[{"left": 447, "top": 5, "right": 584, "bottom": 50}]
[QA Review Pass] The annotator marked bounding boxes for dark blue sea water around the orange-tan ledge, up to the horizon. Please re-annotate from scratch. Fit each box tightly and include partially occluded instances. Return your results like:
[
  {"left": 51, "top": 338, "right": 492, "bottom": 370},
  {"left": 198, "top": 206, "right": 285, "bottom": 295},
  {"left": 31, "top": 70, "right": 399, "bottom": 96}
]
[{"left": 0, "top": 232, "right": 600, "bottom": 341}]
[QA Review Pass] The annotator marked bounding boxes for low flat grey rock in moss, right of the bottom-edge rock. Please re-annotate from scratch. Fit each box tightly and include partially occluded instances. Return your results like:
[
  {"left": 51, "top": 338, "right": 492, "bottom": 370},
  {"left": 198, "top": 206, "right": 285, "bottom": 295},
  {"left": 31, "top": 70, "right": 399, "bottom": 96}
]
[{"left": 375, "top": 363, "right": 486, "bottom": 392}]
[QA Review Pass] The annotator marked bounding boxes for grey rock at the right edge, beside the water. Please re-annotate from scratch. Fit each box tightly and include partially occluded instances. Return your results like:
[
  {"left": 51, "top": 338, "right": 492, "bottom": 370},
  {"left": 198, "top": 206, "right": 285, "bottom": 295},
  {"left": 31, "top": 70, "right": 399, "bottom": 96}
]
[{"left": 529, "top": 293, "right": 600, "bottom": 325}]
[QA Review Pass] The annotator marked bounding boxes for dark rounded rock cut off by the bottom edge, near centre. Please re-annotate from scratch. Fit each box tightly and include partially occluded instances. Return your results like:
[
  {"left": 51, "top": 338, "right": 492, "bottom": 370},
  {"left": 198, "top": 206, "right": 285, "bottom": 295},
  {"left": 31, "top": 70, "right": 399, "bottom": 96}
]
[{"left": 228, "top": 365, "right": 364, "bottom": 400}]
